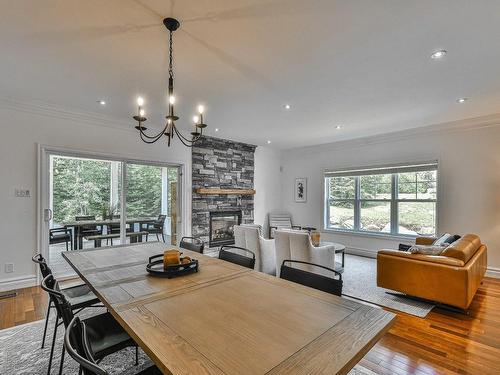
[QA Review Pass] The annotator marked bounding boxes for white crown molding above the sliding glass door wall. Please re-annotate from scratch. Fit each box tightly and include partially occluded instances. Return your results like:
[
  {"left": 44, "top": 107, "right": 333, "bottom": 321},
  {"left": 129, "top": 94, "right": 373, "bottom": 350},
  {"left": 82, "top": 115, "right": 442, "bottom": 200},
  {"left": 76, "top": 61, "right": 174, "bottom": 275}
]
[{"left": 0, "top": 97, "right": 135, "bottom": 132}]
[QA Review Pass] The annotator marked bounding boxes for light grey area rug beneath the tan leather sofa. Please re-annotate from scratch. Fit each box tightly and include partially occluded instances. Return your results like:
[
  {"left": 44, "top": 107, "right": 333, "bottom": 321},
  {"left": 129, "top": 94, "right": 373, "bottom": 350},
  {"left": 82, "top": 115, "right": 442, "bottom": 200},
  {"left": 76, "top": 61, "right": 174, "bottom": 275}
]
[{"left": 342, "top": 254, "right": 435, "bottom": 318}]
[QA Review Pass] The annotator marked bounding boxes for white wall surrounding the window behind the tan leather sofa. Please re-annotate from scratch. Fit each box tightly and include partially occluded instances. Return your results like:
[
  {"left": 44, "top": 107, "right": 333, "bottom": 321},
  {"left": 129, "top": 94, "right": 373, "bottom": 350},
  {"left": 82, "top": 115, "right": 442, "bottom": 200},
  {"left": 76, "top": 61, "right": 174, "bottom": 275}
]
[{"left": 282, "top": 119, "right": 500, "bottom": 272}]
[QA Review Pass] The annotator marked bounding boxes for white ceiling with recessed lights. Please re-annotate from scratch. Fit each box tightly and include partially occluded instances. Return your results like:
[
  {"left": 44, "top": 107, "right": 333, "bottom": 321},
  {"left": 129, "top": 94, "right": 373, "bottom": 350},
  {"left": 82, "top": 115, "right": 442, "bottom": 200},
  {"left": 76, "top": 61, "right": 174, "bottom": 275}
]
[{"left": 0, "top": 0, "right": 500, "bottom": 148}]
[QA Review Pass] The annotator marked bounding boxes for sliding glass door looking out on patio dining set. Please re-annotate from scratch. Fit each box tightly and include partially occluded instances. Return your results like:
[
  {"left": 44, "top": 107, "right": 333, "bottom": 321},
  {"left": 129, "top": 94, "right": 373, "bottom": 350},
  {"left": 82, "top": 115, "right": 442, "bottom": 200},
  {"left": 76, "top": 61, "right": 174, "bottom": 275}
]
[{"left": 42, "top": 153, "right": 180, "bottom": 277}]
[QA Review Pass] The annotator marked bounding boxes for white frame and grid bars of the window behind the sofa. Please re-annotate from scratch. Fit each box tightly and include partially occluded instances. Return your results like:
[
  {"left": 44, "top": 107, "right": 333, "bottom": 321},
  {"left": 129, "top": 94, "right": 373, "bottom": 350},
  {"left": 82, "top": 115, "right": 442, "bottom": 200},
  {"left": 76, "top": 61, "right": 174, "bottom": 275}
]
[{"left": 322, "top": 161, "right": 440, "bottom": 239}]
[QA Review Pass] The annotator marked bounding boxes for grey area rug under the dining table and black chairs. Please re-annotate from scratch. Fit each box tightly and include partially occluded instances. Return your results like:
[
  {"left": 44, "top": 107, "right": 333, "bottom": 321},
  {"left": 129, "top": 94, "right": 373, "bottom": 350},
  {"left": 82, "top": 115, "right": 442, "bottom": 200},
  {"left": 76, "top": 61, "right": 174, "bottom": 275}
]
[{"left": 0, "top": 310, "right": 373, "bottom": 375}]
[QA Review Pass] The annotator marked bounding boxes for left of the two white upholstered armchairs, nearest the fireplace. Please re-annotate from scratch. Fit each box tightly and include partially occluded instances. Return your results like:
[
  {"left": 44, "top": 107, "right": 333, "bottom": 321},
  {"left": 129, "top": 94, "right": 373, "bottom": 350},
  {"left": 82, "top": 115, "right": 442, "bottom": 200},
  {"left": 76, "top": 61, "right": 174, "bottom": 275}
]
[{"left": 234, "top": 225, "right": 276, "bottom": 275}]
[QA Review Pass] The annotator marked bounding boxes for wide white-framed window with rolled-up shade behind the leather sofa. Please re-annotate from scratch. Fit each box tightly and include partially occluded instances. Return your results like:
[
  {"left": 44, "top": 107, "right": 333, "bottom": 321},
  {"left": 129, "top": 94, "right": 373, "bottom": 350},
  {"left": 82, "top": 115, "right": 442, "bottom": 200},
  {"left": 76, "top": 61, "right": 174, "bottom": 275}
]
[{"left": 325, "top": 162, "right": 437, "bottom": 236}]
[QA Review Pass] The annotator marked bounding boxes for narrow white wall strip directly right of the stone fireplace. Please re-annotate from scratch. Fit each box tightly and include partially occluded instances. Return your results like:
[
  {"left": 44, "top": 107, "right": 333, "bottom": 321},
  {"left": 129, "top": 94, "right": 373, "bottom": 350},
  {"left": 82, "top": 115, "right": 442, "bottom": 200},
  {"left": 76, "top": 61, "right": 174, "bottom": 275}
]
[{"left": 254, "top": 146, "right": 282, "bottom": 234}]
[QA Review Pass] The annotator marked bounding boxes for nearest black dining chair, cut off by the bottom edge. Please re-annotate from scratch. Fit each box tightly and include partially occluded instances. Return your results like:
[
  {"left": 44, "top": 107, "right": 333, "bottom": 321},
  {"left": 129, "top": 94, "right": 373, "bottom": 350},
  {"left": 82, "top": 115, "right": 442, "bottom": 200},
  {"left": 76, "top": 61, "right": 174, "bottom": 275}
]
[{"left": 64, "top": 316, "right": 161, "bottom": 375}]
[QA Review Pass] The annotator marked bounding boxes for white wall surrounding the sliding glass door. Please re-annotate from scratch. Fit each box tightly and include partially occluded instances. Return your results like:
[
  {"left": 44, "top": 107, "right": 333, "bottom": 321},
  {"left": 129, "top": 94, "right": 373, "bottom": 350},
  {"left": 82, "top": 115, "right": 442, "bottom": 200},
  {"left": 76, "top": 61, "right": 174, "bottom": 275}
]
[{"left": 0, "top": 103, "right": 191, "bottom": 290}]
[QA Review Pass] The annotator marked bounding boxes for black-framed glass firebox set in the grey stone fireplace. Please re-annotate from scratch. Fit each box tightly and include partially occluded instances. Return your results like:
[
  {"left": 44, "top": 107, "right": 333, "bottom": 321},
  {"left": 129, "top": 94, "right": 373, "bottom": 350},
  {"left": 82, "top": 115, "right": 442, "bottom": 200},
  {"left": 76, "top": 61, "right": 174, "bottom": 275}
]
[{"left": 209, "top": 211, "right": 241, "bottom": 247}]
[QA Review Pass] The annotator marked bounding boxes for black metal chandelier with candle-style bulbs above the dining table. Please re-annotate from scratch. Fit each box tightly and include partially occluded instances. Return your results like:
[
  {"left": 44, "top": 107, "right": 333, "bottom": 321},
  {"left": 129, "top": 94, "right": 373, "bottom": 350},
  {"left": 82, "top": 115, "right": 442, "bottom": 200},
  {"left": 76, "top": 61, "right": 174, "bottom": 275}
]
[{"left": 133, "top": 18, "right": 207, "bottom": 147}]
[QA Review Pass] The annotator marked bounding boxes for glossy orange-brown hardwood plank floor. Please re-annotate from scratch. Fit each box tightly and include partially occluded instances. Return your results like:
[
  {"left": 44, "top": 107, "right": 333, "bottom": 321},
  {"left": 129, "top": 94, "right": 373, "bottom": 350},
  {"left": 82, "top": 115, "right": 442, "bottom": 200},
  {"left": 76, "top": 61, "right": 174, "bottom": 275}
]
[{"left": 0, "top": 278, "right": 500, "bottom": 375}]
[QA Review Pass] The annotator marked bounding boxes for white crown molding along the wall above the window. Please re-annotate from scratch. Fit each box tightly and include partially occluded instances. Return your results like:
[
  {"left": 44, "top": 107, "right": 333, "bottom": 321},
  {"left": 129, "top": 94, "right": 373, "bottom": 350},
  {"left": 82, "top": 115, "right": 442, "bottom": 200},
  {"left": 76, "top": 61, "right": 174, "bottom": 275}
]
[{"left": 283, "top": 113, "right": 500, "bottom": 154}]
